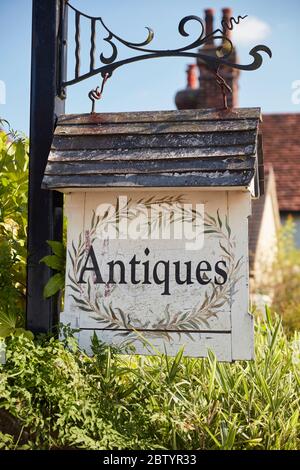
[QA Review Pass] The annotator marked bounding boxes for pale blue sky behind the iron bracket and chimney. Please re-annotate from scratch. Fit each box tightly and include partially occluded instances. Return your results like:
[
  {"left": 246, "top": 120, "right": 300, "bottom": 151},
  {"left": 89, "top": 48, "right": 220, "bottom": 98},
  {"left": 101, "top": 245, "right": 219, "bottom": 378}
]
[{"left": 0, "top": 0, "right": 300, "bottom": 133}]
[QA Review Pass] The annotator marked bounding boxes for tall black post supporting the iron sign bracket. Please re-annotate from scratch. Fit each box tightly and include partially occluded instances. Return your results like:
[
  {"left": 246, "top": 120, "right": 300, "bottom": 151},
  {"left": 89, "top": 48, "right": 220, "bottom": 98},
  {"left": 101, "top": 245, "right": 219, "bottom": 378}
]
[{"left": 26, "top": 0, "right": 66, "bottom": 332}]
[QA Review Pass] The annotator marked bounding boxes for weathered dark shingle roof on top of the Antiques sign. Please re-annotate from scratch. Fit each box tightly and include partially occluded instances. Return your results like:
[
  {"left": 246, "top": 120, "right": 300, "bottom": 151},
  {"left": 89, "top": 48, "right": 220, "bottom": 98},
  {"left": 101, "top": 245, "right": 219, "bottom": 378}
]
[{"left": 43, "top": 108, "right": 261, "bottom": 189}]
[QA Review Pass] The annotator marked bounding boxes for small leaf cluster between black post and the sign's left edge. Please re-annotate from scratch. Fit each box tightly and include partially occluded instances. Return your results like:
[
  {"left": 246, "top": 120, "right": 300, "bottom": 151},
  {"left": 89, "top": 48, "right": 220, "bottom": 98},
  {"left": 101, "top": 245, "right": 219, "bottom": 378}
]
[{"left": 41, "top": 240, "right": 66, "bottom": 298}]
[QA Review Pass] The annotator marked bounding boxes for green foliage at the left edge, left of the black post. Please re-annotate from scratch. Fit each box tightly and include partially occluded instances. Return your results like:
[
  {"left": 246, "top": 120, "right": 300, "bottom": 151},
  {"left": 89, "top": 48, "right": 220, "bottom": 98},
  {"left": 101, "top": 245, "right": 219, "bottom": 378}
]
[{"left": 0, "top": 121, "right": 28, "bottom": 334}]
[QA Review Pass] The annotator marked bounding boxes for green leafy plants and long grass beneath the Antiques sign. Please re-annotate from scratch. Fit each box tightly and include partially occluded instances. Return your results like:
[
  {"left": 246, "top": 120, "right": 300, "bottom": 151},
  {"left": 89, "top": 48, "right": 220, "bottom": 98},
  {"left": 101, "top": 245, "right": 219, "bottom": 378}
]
[{"left": 0, "top": 311, "right": 300, "bottom": 450}]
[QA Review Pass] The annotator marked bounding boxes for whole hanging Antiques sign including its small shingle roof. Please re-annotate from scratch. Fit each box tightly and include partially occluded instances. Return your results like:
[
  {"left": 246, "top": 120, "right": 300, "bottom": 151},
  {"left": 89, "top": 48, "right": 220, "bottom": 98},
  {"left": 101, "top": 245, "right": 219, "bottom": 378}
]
[{"left": 43, "top": 108, "right": 263, "bottom": 361}]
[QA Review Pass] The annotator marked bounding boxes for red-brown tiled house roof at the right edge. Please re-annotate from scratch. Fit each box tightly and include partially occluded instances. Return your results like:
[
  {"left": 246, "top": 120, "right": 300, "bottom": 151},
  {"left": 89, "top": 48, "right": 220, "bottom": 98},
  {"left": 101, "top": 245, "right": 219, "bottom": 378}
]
[{"left": 262, "top": 114, "right": 300, "bottom": 212}]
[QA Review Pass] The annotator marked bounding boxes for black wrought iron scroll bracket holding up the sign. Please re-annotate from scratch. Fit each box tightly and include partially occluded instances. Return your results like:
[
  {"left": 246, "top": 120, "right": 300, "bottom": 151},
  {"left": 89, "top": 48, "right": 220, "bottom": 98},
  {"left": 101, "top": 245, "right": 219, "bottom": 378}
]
[{"left": 59, "top": 1, "right": 272, "bottom": 106}]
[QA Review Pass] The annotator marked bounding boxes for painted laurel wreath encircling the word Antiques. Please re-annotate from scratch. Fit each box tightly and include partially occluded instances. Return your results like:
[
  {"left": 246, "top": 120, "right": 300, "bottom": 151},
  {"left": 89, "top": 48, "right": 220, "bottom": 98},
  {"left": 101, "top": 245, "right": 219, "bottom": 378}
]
[{"left": 68, "top": 196, "right": 243, "bottom": 340}]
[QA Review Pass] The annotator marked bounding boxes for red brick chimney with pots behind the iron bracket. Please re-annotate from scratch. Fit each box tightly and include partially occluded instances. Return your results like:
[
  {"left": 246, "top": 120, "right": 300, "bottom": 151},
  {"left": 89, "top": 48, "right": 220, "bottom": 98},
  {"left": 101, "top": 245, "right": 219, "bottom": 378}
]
[{"left": 175, "top": 8, "right": 240, "bottom": 109}]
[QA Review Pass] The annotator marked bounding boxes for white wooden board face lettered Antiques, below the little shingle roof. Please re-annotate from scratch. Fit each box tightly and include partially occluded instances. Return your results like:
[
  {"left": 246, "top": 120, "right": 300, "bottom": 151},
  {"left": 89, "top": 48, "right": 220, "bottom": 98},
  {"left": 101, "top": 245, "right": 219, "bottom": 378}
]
[{"left": 62, "top": 188, "right": 254, "bottom": 361}]
